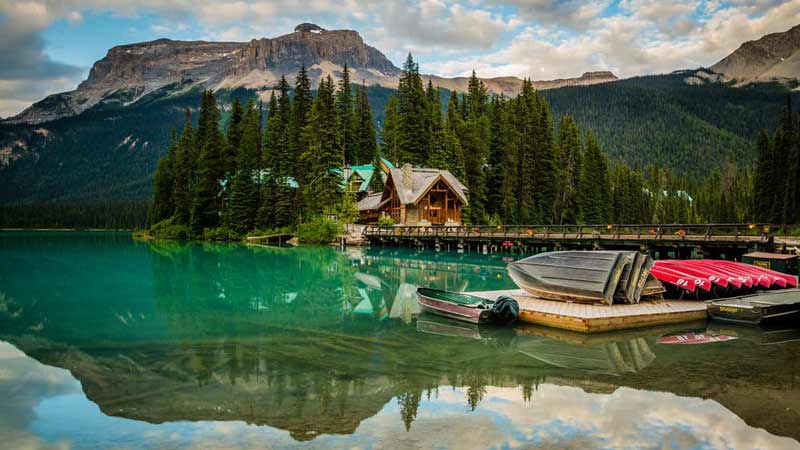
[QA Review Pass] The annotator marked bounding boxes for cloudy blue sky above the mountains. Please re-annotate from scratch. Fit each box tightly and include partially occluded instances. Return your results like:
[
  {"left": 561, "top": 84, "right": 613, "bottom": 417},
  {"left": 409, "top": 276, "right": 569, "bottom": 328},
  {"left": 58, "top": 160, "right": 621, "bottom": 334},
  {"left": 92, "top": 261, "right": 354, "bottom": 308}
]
[{"left": 0, "top": 0, "right": 800, "bottom": 117}]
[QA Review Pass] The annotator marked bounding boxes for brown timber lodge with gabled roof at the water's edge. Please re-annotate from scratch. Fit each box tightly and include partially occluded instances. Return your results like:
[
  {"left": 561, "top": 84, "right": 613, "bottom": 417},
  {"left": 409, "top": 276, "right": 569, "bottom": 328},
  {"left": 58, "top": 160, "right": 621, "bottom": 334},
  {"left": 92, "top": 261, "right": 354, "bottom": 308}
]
[{"left": 358, "top": 164, "right": 468, "bottom": 226}]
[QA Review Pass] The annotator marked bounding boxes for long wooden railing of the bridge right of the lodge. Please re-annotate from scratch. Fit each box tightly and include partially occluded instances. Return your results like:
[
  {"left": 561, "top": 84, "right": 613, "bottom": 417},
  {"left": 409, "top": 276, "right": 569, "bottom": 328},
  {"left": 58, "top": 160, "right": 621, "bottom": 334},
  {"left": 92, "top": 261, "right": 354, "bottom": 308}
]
[{"left": 363, "top": 223, "right": 777, "bottom": 241}]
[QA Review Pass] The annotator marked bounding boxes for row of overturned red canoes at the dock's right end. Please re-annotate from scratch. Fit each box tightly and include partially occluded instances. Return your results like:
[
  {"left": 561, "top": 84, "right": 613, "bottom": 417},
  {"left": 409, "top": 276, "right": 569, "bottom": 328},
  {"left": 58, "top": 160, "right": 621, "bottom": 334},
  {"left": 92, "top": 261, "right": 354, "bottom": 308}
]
[{"left": 650, "top": 259, "right": 797, "bottom": 297}]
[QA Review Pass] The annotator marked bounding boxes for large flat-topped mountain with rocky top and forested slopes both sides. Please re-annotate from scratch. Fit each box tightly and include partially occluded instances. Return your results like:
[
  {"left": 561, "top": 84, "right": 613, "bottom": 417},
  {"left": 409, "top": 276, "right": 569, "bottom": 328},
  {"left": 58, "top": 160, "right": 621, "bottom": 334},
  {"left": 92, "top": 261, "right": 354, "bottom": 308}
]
[{"left": 0, "top": 24, "right": 800, "bottom": 226}]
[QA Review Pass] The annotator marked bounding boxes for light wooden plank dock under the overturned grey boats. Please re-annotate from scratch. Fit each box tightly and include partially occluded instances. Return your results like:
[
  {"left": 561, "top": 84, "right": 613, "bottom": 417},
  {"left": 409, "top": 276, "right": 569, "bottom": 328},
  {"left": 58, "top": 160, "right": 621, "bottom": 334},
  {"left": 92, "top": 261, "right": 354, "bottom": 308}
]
[{"left": 469, "top": 289, "right": 708, "bottom": 333}]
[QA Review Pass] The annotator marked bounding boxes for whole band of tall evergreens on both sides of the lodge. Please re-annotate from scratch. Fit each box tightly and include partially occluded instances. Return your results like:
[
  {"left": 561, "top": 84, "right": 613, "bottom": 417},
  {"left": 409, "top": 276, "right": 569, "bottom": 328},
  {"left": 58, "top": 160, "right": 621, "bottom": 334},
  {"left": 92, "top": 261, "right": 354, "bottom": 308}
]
[{"left": 148, "top": 55, "right": 776, "bottom": 237}]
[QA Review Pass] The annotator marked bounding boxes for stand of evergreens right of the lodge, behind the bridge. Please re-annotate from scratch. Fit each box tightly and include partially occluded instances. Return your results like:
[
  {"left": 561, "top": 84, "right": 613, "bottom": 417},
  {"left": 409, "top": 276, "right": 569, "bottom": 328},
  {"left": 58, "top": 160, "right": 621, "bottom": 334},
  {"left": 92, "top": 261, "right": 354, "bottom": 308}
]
[{"left": 380, "top": 55, "right": 752, "bottom": 224}]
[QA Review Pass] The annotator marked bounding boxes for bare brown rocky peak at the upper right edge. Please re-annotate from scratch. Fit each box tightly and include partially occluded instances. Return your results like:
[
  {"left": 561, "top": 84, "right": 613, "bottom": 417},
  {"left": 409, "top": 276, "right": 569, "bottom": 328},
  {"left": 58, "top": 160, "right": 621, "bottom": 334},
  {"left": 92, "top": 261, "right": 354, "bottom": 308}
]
[{"left": 710, "top": 25, "right": 800, "bottom": 86}]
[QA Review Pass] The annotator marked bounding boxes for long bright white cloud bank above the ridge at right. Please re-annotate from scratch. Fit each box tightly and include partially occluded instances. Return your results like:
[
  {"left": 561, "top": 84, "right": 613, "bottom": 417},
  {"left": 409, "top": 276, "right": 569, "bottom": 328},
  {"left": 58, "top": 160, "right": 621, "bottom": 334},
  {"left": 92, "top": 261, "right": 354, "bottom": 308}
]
[{"left": 423, "top": 0, "right": 800, "bottom": 80}]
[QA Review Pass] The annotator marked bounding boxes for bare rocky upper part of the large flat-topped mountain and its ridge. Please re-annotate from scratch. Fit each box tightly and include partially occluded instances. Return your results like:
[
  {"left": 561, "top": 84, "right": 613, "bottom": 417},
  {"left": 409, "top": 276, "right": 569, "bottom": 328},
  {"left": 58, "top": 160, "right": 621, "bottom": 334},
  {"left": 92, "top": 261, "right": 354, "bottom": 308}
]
[{"left": 8, "top": 23, "right": 616, "bottom": 124}]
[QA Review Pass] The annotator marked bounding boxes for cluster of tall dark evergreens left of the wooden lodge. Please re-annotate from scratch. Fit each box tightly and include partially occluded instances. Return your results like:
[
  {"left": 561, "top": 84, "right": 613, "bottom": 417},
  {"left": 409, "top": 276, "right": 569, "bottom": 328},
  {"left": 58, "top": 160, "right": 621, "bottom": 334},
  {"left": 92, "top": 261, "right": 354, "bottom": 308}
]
[{"left": 148, "top": 67, "right": 378, "bottom": 237}]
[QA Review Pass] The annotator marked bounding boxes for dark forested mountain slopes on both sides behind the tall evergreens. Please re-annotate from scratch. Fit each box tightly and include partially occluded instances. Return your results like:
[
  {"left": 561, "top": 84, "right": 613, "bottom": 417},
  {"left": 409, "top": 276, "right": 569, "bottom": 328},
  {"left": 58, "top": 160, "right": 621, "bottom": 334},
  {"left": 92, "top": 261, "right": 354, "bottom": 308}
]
[{"left": 0, "top": 68, "right": 785, "bottom": 226}]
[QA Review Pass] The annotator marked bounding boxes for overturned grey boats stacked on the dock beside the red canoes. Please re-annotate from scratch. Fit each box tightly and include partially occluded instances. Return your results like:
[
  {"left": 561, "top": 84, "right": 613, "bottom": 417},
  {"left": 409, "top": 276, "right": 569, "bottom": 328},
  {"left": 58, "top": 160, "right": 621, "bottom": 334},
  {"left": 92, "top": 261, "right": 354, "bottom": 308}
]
[{"left": 508, "top": 251, "right": 664, "bottom": 305}]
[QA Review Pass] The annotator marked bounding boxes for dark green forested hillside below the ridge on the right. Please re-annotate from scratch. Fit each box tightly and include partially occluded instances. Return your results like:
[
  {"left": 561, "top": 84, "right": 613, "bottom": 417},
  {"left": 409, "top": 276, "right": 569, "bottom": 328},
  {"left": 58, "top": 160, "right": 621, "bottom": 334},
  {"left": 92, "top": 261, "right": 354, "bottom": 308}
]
[{"left": 542, "top": 72, "right": 797, "bottom": 176}]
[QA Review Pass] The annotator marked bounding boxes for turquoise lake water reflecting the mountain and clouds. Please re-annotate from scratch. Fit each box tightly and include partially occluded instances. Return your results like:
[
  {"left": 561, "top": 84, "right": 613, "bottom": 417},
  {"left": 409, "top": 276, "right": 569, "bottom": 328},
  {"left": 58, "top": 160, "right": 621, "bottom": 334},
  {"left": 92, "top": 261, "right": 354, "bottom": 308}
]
[{"left": 0, "top": 233, "right": 800, "bottom": 449}]
